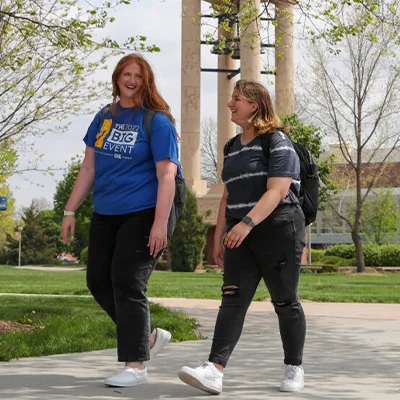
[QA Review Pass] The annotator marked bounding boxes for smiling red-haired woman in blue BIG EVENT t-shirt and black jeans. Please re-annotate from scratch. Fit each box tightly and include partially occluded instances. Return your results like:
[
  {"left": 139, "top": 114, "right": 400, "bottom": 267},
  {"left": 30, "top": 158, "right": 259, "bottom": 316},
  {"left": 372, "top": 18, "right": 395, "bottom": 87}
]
[{"left": 61, "top": 54, "right": 182, "bottom": 387}]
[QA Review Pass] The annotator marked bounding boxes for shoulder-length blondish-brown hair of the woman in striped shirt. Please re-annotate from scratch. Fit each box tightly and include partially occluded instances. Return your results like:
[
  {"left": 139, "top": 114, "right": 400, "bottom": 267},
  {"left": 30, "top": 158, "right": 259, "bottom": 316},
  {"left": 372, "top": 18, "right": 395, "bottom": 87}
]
[{"left": 234, "top": 79, "right": 288, "bottom": 135}]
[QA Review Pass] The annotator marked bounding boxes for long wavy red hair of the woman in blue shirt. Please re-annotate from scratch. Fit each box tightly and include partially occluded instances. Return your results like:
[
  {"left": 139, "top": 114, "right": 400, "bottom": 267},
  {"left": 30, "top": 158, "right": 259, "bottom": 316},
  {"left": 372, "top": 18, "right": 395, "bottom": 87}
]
[{"left": 111, "top": 53, "right": 175, "bottom": 124}]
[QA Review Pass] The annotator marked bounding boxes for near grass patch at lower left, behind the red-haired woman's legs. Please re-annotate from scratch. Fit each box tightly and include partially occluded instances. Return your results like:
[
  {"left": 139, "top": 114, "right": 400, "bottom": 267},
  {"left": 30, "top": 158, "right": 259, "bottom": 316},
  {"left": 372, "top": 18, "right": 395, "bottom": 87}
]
[{"left": 0, "top": 296, "right": 198, "bottom": 361}]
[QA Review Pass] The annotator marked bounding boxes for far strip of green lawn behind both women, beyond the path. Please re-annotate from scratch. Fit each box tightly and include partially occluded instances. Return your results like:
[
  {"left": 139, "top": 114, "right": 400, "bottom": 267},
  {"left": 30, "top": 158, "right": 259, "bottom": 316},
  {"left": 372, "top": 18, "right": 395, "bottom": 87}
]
[{"left": 0, "top": 266, "right": 400, "bottom": 303}]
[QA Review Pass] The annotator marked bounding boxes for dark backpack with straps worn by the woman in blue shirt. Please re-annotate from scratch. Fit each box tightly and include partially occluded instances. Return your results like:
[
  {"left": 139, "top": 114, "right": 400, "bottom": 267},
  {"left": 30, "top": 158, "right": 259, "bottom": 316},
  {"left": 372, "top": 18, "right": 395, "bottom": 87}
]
[{"left": 99, "top": 104, "right": 186, "bottom": 225}]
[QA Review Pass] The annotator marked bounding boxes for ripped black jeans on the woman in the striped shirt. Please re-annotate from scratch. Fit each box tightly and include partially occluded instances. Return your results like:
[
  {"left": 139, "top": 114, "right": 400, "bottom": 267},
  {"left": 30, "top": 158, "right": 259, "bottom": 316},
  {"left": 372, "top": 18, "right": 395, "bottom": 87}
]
[{"left": 209, "top": 205, "right": 306, "bottom": 367}]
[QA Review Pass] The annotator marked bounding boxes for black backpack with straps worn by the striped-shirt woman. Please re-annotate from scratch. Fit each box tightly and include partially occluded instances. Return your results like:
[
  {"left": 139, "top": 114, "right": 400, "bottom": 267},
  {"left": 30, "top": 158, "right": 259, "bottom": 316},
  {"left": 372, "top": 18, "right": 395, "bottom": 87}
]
[{"left": 224, "top": 131, "right": 319, "bottom": 226}]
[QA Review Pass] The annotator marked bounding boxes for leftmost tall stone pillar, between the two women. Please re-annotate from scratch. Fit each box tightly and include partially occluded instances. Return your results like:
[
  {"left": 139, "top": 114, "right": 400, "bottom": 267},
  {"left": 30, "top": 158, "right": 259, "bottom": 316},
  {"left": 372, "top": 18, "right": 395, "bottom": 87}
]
[{"left": 181, "top": 0, "right": 207, "bottom": 196}]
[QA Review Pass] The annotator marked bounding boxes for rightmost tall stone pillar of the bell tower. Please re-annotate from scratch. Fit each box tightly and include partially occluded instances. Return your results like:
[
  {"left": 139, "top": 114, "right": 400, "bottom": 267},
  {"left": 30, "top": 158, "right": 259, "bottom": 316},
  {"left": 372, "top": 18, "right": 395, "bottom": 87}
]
[{"left": 275, "top": 1, "right": 294, "bottom": 117}]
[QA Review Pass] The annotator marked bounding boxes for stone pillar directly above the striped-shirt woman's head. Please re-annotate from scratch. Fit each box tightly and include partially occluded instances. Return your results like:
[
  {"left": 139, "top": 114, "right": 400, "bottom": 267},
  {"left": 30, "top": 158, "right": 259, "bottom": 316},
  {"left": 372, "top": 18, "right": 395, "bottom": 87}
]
[{"left": 240, "top": 0, "right": 261, "bottom": 81}]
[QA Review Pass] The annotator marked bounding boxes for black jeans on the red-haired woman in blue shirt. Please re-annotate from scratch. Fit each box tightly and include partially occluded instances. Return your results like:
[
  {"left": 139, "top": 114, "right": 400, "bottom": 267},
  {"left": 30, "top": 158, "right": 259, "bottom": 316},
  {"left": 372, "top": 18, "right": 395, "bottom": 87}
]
[{"left": 86, "top": 208, "right": 157, "bottom": 362}]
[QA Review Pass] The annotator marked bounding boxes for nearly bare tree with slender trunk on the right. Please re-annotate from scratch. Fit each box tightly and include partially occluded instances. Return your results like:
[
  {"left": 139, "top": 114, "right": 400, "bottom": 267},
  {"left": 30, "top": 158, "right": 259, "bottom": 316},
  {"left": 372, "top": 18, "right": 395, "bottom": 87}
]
[{"left": 301, "top": 6, "right": 400, "bottom": 272}]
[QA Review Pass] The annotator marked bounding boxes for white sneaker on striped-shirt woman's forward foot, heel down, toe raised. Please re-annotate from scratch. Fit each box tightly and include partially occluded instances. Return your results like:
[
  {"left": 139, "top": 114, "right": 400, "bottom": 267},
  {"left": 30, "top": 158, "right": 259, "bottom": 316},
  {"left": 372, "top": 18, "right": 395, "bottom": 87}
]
[{"left": 178, "top": 361, "right": 224, "bottom": 394}]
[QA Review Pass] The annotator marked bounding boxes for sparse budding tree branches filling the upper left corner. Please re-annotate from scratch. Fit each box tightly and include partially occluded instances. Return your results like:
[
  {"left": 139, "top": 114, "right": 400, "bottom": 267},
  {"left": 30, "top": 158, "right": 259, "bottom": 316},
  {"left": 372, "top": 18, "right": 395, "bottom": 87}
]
[{"left": 0, "top": 0, "right": 159, "bottom": 141}]
